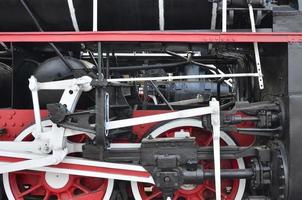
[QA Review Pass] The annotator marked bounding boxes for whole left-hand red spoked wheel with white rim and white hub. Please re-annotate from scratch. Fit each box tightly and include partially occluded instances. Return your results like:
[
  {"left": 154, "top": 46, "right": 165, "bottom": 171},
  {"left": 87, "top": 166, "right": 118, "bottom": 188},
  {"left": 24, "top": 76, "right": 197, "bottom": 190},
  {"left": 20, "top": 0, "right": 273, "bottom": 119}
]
[{"left": 3, "top": 120, "right": 114, "bottom": 200}]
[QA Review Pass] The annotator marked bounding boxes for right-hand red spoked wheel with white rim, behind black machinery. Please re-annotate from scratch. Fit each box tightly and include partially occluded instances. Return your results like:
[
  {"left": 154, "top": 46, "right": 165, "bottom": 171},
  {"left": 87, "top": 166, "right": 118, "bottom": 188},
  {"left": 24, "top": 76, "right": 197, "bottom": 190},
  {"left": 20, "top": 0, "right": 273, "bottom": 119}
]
[{"left": 131, "top": 119, "right": 246, "bottom": 200}]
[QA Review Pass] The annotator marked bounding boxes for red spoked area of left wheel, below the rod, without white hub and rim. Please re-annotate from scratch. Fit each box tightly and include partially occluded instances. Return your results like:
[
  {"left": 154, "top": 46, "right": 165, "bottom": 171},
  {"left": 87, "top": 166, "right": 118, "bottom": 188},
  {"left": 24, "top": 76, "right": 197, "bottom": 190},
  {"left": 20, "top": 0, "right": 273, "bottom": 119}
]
[{"left": 9, "top": 170, "right": 108, "bottom": 200}]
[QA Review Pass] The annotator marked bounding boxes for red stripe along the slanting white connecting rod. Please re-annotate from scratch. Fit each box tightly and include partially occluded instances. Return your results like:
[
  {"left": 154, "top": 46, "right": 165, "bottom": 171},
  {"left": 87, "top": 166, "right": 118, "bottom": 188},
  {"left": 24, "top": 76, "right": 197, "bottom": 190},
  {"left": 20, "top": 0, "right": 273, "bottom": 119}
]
[{"left": 0, "top": 156, "right": 150, "bottom": 178}]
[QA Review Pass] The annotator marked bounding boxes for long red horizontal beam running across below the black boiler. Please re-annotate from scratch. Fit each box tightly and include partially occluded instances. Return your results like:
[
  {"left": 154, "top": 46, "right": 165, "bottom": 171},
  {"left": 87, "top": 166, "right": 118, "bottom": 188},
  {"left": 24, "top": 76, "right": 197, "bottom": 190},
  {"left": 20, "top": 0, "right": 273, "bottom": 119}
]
[{"left": 0, "top": 31, "right": 302, "bottom": 43}]
